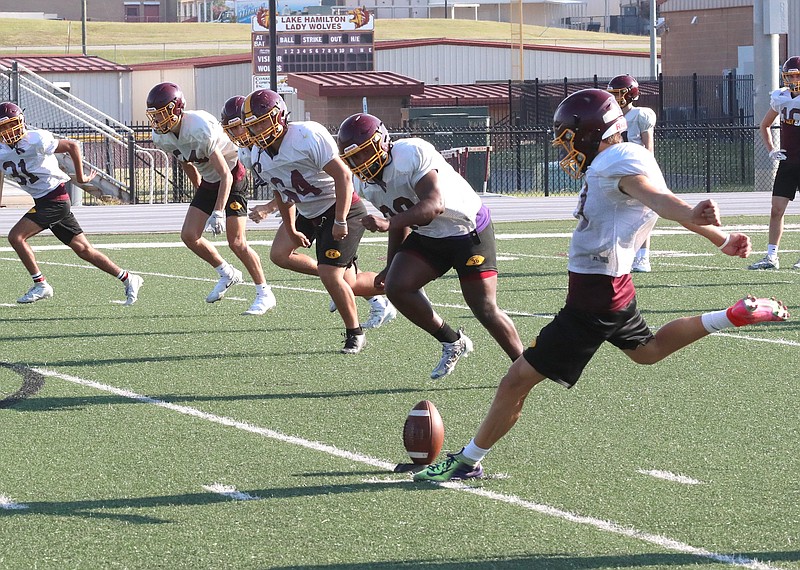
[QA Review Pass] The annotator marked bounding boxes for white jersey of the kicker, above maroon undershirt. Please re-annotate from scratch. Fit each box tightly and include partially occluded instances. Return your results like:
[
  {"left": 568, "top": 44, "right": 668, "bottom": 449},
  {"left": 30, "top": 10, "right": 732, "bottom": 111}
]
[{"left": 568, "top": 143, "right": 667, "bottom": 277}]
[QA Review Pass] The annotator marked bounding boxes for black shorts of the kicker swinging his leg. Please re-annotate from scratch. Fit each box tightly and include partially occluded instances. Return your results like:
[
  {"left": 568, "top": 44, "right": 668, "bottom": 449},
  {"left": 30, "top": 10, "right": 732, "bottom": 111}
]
[{"left": 522, "top": 298, "right": 653, "bottom": 388}]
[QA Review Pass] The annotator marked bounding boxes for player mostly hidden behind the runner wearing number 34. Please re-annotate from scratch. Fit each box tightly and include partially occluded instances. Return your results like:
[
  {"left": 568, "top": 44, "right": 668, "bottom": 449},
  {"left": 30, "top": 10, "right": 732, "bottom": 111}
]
[{"left": 220, "top": 96, "right": 397, "bottom": 329}]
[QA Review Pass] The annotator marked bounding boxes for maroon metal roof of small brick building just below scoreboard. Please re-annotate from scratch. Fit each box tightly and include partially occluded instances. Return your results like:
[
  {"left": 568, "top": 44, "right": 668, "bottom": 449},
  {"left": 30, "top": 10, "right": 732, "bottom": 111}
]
[{"left": 287, "top": 71, "right": 425, "bottom": 97}]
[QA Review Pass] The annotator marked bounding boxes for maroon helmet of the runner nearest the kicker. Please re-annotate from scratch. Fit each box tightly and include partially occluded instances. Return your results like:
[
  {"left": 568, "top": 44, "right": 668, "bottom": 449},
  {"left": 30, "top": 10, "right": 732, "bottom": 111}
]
[{"left": 337, "top": 113, "right": 392, "bottom": 182}]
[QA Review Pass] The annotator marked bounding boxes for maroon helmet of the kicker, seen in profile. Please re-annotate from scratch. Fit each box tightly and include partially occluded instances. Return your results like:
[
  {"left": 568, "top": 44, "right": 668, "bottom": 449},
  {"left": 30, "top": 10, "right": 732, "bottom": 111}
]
[{"left": 553, "top": 89, "right": 628, "bottom": 179}]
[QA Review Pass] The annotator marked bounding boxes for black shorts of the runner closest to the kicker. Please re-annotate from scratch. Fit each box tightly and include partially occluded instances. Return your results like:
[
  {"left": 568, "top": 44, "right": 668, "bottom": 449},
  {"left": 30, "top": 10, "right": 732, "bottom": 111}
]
[{"left": 400, "top": 220, "right": 497, "bottom": 279}]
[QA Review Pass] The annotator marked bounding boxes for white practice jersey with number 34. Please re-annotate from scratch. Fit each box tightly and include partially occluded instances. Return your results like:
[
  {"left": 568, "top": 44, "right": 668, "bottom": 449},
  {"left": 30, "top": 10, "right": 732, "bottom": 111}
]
[{"left": 252, "top": 121, "right": 339, "bottom": 218}]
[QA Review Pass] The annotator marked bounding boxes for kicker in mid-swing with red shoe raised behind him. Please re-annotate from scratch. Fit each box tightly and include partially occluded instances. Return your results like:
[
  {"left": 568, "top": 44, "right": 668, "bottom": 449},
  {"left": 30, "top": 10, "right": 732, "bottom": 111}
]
[{"left": 414, "top": 89, "right": 789, "bottom": 481}]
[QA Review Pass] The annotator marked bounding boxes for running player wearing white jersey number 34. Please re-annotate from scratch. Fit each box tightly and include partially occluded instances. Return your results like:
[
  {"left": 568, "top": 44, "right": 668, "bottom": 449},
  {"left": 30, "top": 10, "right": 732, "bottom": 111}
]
[{"left": 243, "top": 89, "right": 397, "bottom": 354}]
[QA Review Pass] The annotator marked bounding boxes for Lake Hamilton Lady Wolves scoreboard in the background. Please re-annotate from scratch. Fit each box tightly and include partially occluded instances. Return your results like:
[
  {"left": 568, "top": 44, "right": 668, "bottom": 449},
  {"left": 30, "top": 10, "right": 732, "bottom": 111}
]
[{"left": 252, "top": 8, "right": 375, "bottom": 91}]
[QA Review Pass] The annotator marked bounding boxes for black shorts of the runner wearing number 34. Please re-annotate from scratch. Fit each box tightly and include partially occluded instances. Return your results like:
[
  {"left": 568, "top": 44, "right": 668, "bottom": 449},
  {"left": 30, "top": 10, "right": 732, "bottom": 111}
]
[{"left": 294, "top": 196, "right": 367, "bottom": 267}]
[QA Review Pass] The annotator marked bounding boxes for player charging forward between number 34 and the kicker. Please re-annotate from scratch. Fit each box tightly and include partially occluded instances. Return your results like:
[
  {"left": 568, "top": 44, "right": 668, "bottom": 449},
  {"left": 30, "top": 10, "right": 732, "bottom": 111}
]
[{"left": 338, "top": 113, "right": 522, "bottom": 379}]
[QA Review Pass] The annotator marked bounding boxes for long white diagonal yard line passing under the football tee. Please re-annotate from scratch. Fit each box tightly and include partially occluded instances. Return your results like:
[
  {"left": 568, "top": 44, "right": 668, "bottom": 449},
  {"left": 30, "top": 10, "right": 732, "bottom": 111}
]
[{"left": 31, "top": 368, "right": 780, "bottom": 570}]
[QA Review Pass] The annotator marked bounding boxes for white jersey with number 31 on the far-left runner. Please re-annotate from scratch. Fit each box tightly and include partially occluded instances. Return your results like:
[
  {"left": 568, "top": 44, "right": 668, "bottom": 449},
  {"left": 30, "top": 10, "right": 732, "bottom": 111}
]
[{"left": 0, "top": 129, "right": 69, "bottom": 199}]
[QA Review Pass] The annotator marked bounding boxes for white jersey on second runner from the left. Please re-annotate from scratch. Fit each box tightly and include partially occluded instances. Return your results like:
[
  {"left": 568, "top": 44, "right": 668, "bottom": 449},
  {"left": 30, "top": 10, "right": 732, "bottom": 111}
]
[{"left": 153, "top": 111, "right": 237, "bottom": 184}]
